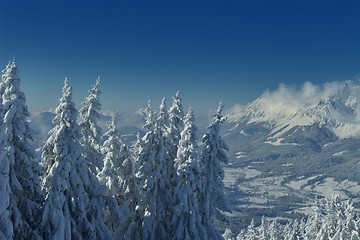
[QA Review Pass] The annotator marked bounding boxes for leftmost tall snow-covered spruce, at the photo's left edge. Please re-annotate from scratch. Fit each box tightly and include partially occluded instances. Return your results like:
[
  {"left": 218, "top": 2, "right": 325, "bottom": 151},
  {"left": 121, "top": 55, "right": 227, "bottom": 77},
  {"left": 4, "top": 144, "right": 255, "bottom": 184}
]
[{"left": 0, "top": 60, "right": 43, "bottom": 239}]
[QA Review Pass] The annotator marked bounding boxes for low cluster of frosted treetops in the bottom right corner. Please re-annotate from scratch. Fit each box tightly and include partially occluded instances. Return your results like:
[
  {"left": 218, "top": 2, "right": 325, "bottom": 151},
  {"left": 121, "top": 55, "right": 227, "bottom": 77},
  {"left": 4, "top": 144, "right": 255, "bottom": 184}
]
[{"left": 223, "top": 195, "right": 360, "bottom": 240}]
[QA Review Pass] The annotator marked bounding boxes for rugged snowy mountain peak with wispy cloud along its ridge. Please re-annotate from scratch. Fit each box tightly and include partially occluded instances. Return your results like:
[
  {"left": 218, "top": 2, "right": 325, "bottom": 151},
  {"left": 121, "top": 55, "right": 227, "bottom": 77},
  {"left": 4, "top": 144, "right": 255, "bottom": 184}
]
[{"left": 227, "top": 81, "right": 360, "bottom": 138}]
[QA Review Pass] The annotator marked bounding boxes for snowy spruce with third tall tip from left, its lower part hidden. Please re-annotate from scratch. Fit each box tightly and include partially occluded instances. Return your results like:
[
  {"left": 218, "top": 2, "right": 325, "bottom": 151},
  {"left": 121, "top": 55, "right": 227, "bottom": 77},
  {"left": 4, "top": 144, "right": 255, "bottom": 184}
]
[{"left": 79, "top": 78, "right": 103, "bottom": 174}]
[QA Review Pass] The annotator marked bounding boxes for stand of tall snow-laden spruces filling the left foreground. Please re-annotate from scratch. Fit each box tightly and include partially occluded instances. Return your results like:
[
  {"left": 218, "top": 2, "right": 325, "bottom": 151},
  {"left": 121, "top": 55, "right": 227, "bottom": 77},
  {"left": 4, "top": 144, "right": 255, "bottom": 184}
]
[{"left": 0, "top": 61, "right": 229, "bottom": 240}]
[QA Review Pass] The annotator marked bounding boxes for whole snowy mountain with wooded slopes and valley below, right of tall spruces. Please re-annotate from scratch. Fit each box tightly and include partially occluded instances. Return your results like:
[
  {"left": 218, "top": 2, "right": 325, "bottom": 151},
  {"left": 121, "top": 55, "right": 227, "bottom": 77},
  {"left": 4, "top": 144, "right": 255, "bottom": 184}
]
[{"left": 223, "top": 81, "right": 360, "bottom": 227}]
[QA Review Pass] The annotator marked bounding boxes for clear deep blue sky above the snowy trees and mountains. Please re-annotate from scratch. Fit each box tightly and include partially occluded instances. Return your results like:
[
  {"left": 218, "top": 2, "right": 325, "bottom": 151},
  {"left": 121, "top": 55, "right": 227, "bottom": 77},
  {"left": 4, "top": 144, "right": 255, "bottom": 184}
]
[{"left": 0, "top": 0, "right": 360, "bottom": 111}]
